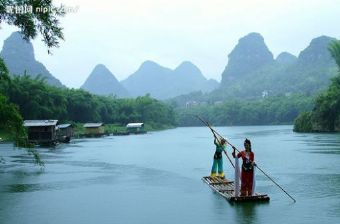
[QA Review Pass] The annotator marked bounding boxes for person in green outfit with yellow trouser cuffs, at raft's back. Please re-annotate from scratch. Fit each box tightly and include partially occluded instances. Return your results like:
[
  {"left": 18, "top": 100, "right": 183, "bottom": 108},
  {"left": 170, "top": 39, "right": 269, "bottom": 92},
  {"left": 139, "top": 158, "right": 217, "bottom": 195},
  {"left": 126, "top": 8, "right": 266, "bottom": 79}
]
[{"left": 210, "top": 136, "right": 226, "bottom": 178}]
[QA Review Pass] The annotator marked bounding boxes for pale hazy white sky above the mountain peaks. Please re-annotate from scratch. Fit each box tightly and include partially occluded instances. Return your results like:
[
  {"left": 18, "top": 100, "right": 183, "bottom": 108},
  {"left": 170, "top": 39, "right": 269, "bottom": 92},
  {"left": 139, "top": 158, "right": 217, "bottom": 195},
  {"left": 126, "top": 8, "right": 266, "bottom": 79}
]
[{"left": 0, "top": 0, "right": 340, "bottom": 88}]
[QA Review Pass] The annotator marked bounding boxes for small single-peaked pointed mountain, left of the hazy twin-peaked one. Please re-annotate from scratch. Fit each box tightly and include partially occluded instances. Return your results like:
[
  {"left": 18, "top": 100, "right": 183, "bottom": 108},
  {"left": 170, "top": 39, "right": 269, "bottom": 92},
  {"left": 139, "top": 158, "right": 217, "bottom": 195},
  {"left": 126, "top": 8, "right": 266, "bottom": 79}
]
[{"left": 81, "top": 64, "right": 129, "bottom": 97}]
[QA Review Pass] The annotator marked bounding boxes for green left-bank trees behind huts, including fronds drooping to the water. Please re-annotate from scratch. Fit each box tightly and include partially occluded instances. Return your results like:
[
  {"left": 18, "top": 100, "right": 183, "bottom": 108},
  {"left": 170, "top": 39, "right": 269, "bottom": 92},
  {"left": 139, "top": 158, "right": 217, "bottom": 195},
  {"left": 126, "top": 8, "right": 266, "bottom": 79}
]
[{"left": 0, "top": 55, "right": 175, "bottom": 164}]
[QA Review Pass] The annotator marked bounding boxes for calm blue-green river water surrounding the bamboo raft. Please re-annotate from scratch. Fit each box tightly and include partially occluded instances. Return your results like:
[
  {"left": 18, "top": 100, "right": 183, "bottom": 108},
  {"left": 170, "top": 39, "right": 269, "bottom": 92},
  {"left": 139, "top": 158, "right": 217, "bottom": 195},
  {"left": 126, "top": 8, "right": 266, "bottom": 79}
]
[{"left": 0, "top": 126, "right": 340, "bottom": 224}]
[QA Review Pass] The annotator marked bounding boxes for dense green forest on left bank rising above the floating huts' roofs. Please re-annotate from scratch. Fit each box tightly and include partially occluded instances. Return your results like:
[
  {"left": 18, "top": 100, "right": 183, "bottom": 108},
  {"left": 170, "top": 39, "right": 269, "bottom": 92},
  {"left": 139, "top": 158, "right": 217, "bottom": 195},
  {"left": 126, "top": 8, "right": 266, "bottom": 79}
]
[{"left": 0, "top": 59, "right": 175, "bottom": 131}]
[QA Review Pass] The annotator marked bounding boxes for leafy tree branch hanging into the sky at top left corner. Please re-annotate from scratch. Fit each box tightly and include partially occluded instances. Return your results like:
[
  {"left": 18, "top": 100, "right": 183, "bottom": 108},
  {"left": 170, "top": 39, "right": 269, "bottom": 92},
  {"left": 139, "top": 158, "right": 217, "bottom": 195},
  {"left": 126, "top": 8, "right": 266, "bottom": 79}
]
[{"left": 0, "top": 0, "right": 65, "bottom": 51}]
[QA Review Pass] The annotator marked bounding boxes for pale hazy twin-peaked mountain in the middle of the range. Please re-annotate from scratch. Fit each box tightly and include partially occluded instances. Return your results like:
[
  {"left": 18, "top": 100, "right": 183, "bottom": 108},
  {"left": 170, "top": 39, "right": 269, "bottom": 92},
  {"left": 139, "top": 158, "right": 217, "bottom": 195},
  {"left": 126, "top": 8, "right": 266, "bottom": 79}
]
[{"left": 121, "top": 61, "right": 218, "bottom": 99}]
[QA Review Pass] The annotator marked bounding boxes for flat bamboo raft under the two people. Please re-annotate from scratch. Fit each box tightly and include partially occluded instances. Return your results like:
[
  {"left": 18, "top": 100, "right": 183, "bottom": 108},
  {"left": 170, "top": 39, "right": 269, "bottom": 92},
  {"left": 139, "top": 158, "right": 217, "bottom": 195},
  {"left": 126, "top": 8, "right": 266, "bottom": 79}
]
[{"left": 202, "top": 176, "right": 270, "bottom": 202}]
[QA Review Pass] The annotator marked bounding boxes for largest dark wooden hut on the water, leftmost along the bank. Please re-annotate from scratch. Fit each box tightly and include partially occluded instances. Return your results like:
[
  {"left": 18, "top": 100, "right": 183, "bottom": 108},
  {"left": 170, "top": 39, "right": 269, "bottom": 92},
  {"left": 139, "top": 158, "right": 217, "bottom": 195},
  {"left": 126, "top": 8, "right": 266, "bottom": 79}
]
[{"left": 24, "top": 120, "right": 58, "bottom": 145}]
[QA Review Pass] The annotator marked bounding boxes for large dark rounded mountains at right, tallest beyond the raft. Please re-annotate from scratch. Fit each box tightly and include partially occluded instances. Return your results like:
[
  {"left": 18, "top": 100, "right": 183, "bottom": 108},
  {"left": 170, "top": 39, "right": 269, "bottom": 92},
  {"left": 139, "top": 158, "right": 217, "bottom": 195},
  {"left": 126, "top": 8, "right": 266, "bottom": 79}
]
[{"left": 216, "top": 33, "right": 337, "bottom": 98}]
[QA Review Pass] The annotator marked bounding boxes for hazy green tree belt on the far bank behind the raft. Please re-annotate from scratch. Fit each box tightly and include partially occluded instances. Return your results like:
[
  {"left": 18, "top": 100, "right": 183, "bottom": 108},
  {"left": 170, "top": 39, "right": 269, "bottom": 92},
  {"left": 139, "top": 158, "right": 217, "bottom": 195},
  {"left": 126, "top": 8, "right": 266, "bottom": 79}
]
[{"left": 176, "top": 95, "right": 312, "bottom": 126}]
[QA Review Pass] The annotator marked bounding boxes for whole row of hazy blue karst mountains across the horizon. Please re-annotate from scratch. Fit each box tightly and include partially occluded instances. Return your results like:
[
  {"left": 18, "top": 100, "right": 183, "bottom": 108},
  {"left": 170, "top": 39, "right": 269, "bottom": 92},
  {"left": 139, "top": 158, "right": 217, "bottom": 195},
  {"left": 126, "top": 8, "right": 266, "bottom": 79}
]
[{"left": 0, "top": 32, "right": 337, "bottom": 101}]
